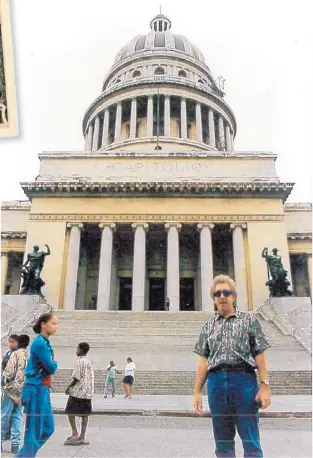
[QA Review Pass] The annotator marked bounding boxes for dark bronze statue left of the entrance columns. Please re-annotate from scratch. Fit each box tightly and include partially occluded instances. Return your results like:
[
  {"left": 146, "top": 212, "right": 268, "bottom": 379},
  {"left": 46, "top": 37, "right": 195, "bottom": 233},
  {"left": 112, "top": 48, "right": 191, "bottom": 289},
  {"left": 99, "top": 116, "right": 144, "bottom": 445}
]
[{"left": 20, "top": 245, "right": 51, "bottom": 297}]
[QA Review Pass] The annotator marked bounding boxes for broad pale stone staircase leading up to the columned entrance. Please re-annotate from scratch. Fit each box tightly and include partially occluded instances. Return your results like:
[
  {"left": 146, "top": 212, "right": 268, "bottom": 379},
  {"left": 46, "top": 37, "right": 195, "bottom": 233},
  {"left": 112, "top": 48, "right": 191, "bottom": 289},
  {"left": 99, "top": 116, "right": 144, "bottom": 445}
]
[{"left": 17, "top": 311, "right": 311, "bottom": 394}]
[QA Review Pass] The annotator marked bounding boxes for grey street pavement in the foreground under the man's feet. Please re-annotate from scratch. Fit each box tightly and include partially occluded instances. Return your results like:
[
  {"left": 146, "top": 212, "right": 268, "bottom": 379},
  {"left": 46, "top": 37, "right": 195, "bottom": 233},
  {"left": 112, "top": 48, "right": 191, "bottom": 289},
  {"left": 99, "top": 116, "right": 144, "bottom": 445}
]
[{"left": 4, "top": 415, "right": 312, "bottom": 458}]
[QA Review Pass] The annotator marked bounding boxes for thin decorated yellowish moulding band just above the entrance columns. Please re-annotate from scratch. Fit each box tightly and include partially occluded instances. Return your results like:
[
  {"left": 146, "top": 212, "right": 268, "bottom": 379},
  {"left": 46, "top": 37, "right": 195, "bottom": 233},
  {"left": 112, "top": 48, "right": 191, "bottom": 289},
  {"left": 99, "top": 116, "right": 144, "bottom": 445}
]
[{"left": 30, "top": 213, "right": 285, "bottom": 225}]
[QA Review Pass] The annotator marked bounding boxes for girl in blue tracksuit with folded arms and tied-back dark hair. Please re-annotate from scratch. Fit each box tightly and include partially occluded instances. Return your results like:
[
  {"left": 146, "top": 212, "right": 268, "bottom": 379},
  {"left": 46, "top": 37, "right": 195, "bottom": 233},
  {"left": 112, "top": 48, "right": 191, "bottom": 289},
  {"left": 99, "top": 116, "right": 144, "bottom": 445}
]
[{"left": 15, "top": 312, "right": 58, "bottom": 458}]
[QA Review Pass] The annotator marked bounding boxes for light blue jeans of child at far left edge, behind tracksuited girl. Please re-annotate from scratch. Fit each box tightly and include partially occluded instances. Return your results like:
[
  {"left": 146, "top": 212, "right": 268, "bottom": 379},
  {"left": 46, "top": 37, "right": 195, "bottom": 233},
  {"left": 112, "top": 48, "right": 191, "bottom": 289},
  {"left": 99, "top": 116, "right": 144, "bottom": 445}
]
[{"left": 1, "top": 394, "right": 23, "bottom": 449}]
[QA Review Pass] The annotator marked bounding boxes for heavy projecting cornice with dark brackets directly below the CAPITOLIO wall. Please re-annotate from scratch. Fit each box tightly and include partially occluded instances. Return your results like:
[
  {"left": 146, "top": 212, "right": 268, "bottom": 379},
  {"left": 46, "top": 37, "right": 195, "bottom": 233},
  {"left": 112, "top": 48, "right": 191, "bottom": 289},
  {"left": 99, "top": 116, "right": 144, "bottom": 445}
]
[{"left": 21, "top": 180, "right": 294, "bottom": 201}]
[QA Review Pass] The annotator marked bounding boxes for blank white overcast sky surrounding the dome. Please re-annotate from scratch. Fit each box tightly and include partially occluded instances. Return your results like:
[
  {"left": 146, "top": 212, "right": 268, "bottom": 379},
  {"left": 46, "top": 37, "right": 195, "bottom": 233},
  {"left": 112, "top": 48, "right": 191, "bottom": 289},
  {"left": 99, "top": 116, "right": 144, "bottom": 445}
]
[{"left": 0, "top": 0, "right": 313, "bottom": 202}]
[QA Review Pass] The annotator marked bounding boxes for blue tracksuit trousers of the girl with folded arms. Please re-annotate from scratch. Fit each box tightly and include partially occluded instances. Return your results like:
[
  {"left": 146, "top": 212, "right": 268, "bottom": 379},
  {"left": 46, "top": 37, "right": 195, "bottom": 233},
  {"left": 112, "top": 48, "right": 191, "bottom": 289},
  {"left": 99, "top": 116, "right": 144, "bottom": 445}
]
[{"left": 15, "top": 384, "right": 54, "bottom": 457}]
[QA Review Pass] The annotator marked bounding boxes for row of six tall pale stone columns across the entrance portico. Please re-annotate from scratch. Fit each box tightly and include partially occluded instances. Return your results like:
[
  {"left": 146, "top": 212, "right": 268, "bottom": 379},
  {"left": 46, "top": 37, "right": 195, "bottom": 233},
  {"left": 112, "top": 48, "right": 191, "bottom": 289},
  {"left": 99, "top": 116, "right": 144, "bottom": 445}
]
[{"left": 63, "top": 222, "right": 248, "bottom": 312}]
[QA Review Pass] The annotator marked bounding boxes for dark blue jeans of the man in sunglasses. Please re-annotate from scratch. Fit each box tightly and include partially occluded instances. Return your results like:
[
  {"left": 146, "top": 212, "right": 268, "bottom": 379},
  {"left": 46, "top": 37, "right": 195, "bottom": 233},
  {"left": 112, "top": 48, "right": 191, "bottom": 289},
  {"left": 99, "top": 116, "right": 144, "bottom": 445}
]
[{"left": 208, "top": 372, "right": 263, "bottom": 458}]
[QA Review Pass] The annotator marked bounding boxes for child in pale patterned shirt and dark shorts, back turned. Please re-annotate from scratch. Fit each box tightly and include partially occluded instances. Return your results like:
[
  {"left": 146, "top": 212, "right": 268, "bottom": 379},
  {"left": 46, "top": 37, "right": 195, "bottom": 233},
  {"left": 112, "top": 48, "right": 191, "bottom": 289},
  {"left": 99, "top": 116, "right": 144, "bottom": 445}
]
[{"left": 64, "top": 342, "right": 95, "bottom": 445}]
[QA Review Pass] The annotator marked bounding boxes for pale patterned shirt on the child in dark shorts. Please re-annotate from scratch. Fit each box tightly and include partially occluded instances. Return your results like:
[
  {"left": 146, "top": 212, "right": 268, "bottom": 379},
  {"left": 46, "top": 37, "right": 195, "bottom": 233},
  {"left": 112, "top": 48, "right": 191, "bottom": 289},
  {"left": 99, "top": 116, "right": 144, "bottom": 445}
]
[{"left": 69, "top": 356, "right": 95, "bottom": 399}]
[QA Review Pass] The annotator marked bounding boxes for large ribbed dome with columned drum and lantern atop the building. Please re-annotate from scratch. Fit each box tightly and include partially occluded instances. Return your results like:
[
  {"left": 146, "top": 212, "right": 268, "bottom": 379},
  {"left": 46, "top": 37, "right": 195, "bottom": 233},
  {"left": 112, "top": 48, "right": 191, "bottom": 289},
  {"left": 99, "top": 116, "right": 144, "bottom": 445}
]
[{"left": 83, "top": 15, "right": 236, "bottom": 154}]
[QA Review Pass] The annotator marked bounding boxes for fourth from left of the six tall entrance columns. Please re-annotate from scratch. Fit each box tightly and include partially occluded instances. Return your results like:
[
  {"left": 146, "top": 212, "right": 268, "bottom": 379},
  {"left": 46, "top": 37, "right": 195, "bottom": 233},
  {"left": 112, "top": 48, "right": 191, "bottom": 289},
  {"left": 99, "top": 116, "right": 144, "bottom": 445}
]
[{"left": 165, "top": 223, "right": 181, "bottom": 312}]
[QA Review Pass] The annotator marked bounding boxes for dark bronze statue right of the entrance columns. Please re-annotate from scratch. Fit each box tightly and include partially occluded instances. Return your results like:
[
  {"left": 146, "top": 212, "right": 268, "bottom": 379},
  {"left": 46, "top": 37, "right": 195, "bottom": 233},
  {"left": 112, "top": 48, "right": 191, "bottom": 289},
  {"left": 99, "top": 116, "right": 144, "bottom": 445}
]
[{"left": 262, "top": 247, "right": 293, "bottom": 297}]
